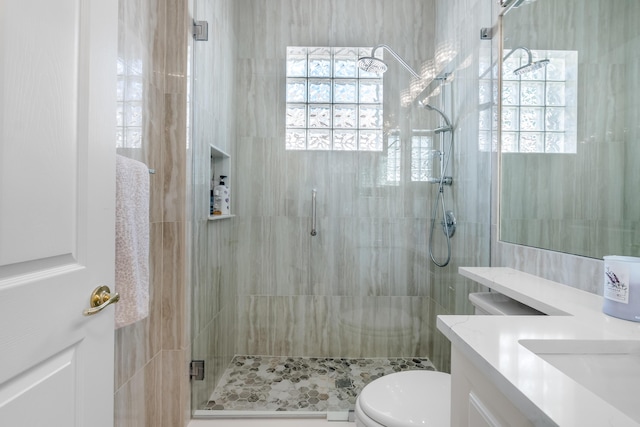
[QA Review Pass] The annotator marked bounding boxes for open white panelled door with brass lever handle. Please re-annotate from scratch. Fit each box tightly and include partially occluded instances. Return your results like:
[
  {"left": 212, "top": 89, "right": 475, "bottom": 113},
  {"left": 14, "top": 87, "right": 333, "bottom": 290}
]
[{"left": 0, "top": 0, "right": 118, "bottom": 427}]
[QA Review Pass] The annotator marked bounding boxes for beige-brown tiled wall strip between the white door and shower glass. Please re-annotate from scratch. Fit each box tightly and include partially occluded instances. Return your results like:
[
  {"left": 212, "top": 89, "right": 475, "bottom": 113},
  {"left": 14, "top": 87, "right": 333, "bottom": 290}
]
[{"left": 114, "top": 0, "right": 190, "bottom": 427}]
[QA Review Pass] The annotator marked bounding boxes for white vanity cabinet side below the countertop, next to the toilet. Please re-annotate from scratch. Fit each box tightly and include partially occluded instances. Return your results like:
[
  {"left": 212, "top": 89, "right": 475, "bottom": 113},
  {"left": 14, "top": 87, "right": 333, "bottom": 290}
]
[{"left": 451, "top": 346, "right": 534, "bottom": 427}]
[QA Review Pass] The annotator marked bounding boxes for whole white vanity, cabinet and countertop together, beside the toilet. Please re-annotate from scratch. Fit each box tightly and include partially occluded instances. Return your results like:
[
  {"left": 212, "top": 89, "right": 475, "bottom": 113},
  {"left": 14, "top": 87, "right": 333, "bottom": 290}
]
[{"left": 437, "top": 267, "right": 640, "bottom": 427}]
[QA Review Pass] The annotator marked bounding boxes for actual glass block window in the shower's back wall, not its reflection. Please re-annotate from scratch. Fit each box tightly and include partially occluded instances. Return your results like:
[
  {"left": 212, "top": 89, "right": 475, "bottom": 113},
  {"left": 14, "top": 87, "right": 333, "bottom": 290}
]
[{"left": 285, "top": 47, "right": 383, "bottom": 151}]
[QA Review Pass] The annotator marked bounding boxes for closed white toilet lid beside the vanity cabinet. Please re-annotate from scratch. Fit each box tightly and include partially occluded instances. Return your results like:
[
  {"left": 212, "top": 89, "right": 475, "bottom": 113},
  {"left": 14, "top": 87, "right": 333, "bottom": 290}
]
[{"left": 359, "top": 371, "right": 451, "bottom": 427}]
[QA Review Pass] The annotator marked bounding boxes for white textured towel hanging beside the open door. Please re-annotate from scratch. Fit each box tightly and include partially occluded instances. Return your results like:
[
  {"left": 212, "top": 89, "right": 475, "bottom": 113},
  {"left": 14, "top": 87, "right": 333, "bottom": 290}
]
[{"left": 115, "top": 155, "right": 149, "bottom": 328}]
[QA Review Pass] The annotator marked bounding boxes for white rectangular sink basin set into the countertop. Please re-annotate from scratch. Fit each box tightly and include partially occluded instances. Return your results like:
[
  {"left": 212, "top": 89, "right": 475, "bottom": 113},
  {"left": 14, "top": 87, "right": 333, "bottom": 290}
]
[{"left": 519, "top": 340, "right": 640, "bottom": 422}]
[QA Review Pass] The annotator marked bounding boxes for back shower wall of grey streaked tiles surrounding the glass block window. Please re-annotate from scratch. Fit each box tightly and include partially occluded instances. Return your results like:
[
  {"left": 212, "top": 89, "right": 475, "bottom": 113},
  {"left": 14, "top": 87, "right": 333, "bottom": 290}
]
[{"left": 233, "top": 0, "right": 434, "bottom": 357}]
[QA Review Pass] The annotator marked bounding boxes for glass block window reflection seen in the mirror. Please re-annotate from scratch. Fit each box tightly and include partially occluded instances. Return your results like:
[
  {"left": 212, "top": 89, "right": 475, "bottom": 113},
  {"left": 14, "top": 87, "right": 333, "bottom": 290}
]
[{"left": 502, "top": 51, "right": 578, "bottom": 153}]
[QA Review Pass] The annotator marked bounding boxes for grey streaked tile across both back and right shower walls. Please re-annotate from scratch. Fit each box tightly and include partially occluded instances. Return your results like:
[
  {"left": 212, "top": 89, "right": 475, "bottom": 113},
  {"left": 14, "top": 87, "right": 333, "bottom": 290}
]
[{"left": 231, "top": 0, "right": 491, "bottom": 370}]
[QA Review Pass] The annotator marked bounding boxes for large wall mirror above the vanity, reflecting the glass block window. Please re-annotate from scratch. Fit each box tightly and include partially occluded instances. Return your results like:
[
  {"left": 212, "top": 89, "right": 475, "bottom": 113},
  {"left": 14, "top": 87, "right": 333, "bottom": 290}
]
[{"left": 500, "top": 0, "right": 640, "bottom": 258}]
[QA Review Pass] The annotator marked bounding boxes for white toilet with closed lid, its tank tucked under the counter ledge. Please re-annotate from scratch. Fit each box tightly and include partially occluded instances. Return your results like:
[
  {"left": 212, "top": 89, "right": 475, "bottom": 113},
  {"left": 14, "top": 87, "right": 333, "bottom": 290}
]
[{"left": 355, "top": 292, "right": 543, "bottom": 427}]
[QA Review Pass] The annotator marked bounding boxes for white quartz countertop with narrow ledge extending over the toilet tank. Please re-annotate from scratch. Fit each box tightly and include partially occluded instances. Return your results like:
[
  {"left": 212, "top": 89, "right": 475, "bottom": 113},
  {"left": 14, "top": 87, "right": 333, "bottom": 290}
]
[{"left": 438, "top": 267, "right": 640, "bottom": 427}]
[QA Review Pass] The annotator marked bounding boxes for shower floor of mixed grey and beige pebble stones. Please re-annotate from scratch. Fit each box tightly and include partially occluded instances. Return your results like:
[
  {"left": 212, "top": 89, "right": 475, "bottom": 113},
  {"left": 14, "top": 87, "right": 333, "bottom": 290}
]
[{"left": 203, "top": 356, "right": 435, "bottom": 412}]
